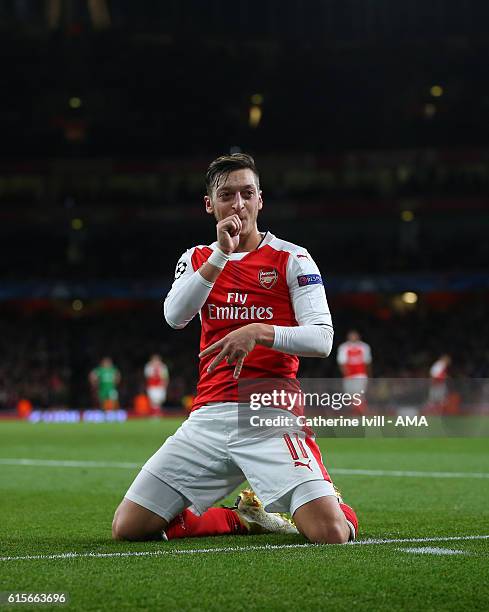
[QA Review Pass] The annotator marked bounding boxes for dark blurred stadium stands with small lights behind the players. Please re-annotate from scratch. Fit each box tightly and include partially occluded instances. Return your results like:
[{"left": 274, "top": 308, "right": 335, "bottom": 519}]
[{"left": 0, "top": 0, "right": 489, "bottom": 412}]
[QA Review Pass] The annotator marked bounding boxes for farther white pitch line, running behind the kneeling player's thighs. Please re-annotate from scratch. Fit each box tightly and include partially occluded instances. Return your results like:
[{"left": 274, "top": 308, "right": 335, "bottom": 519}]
[{"left": 0, "top": 458, "right": 489, "bottom": 479}]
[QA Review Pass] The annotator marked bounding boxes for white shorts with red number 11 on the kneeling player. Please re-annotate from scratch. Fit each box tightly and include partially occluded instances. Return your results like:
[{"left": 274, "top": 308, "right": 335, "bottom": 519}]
[{"left": 125, "top": 403, "right": 335, "bottom": 520}]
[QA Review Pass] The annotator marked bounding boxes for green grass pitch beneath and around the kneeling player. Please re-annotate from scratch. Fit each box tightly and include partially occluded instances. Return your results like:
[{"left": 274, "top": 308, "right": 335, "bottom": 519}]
[{"left": 0, "top": 419, "right": 489, "bottom": 611}]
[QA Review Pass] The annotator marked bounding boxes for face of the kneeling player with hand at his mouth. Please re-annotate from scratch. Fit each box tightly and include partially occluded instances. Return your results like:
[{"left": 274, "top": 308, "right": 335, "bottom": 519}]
[{"left": 204, "top": 168, "right": 263, "bottom": 236}]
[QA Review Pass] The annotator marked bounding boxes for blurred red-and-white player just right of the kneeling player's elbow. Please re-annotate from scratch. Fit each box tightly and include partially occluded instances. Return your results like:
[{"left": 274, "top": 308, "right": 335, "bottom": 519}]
[{"left": 336, "top": 329, "right": 372, "bottom": 413}]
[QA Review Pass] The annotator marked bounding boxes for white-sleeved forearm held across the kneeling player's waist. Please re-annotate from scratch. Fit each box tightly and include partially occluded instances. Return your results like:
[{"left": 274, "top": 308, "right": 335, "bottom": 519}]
[{"left": 272, "top": 325, "right": 333, "bottom": 358}]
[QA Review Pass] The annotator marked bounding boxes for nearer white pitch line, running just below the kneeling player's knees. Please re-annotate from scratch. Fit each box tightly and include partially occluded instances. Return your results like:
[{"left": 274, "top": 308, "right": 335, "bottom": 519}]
[{"left": 0, "top": 535, "right": 489, "bottom": 561}]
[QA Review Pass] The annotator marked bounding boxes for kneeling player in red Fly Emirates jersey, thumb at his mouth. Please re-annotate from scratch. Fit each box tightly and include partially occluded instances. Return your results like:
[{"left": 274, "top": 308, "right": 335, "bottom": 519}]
[{"left": 112, "top": 154, "right": 358, "bottom": 543}]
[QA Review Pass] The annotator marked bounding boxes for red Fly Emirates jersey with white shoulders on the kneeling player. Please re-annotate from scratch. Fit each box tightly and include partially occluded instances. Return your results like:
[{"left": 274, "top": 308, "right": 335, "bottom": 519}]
[{"left": 168, "top": 232, "right": 332, "bottom": 410}]
